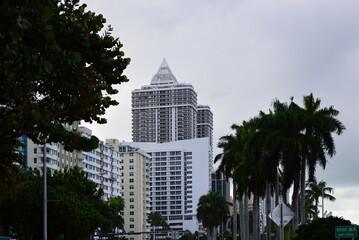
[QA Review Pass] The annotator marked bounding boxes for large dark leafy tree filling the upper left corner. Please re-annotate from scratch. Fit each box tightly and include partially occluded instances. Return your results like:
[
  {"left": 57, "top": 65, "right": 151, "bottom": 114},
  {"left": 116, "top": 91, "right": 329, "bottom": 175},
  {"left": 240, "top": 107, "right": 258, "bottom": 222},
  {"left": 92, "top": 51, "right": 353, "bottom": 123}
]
[{"left": 0, "top": 0, "right": 129, "bottom": 200}]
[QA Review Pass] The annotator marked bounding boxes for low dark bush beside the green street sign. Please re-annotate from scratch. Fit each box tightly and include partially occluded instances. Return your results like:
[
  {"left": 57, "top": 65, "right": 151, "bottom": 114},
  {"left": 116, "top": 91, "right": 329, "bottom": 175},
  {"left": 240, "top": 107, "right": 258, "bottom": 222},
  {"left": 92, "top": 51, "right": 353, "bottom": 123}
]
[{"left": 293, "top": 216, "right": 353, "bottom": 240}]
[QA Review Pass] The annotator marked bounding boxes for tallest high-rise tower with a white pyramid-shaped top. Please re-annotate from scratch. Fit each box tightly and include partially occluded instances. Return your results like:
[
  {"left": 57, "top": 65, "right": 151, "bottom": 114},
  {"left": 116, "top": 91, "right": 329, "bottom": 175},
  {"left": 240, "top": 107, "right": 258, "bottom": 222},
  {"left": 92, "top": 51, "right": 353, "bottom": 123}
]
[{"left": 132, "top": 60, "right": 197, "bottom": 143}]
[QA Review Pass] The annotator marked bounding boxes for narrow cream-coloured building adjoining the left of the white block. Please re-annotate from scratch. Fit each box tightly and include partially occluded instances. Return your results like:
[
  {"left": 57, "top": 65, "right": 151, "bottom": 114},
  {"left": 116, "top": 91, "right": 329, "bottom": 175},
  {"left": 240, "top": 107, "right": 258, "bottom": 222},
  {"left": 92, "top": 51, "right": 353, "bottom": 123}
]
[{"left": 106, "top": 139, "right": 151, "bottom": 240}]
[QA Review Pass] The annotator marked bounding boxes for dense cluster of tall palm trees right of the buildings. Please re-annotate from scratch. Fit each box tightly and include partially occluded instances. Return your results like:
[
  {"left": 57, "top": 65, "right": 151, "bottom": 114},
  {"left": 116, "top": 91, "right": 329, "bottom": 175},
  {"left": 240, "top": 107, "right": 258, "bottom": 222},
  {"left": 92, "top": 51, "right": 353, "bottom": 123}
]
[{"left": 215, "top": 94, "right": 345, "bottom": 238}]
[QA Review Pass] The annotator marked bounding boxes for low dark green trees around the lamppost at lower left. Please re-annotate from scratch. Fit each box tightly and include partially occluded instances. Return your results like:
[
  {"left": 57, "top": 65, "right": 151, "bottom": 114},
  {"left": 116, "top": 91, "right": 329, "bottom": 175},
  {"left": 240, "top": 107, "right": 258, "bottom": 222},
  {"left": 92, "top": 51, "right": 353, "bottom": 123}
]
[{"left": 0, "top": 167, "right": 124, "bottom": 240}]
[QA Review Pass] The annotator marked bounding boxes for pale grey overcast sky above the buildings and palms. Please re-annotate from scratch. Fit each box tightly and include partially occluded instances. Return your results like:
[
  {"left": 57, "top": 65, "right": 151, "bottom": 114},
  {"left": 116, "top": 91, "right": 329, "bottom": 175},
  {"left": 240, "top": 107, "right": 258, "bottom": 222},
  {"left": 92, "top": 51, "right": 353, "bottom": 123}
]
[{"left": 82, "top": 0, "right": 359, "bottom": 224}]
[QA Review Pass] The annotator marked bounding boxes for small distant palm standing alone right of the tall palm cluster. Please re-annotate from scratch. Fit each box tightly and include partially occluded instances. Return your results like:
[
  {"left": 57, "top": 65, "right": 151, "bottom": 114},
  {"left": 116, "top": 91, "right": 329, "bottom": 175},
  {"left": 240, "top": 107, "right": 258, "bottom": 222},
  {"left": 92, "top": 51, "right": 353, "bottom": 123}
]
[{"left": 305, "top": 181, "right": 335, "bottom": 219}]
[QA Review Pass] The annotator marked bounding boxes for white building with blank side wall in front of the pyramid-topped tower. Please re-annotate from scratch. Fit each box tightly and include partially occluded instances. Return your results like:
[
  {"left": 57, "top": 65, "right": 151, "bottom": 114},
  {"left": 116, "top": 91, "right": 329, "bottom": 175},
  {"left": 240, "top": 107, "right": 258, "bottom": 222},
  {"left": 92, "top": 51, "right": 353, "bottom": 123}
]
[{"left": 121, "top": 138, "right": 211, "bottom": 232}]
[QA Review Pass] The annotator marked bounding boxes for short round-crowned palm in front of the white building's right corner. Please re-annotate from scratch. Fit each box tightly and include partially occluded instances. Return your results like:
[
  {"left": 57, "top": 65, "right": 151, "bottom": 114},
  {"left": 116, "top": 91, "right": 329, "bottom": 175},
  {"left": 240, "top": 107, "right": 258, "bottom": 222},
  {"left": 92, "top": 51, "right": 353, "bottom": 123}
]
[{"left": 197, "top": 191, "right": 229, "bottom": 240}]
